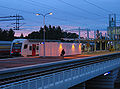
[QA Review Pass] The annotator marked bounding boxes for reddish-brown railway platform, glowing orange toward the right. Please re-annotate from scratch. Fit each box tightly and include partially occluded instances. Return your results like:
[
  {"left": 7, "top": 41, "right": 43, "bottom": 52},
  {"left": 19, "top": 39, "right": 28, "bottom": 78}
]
[{"left": 0, "top": 51, "right": 119, "bottom": 70}]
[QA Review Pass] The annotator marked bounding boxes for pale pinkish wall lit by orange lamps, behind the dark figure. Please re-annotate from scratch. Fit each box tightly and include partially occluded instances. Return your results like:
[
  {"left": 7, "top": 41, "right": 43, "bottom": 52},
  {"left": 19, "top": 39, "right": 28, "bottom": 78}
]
[{"left": 39, "top": 42, "right": 81, "bottom": 56}]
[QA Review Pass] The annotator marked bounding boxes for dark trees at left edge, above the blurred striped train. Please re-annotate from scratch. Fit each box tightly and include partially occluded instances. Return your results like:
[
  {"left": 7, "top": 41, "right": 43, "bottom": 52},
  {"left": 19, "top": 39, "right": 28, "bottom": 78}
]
[{"left": 0, "top": 28, "right": 15, "bottom": 41}]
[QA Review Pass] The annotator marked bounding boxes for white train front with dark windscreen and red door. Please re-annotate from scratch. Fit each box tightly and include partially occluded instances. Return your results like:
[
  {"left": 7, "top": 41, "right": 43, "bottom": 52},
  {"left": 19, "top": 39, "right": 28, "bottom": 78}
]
[{"left": 10, "top": 39, "right": 40, "bottom": 56}]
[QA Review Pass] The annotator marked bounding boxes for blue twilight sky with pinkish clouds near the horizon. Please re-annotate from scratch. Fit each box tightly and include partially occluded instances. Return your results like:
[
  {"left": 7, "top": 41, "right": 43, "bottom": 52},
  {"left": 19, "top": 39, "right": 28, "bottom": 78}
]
[{"left": 0, "top": 0, "right": 120, "bottom": 35}]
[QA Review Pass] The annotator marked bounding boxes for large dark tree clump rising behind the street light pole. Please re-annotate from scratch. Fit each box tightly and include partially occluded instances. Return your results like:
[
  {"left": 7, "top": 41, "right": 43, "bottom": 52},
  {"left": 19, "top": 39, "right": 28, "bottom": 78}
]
[{"left": 27, "top": 25, "right": 78, "bottom": 40}]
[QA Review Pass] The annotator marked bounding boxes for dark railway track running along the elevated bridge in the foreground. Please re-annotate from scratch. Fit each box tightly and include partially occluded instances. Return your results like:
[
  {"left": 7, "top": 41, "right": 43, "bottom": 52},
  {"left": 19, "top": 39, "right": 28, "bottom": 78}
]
[{"left": 0, "top": 54, "right": 120, "bottom": 85}]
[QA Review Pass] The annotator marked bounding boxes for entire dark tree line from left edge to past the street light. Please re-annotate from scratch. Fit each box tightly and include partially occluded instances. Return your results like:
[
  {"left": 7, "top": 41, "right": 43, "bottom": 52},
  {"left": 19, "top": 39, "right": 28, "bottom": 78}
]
[{"left": 0, "top": 25, "right": 78, "bottom": 41}]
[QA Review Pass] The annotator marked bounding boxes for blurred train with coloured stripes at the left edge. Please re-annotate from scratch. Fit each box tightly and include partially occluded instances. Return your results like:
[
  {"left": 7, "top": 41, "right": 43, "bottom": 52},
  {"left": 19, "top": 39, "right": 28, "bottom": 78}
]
[{"left": 0, "top": 41, "right": 12, "bottom": 55}]
